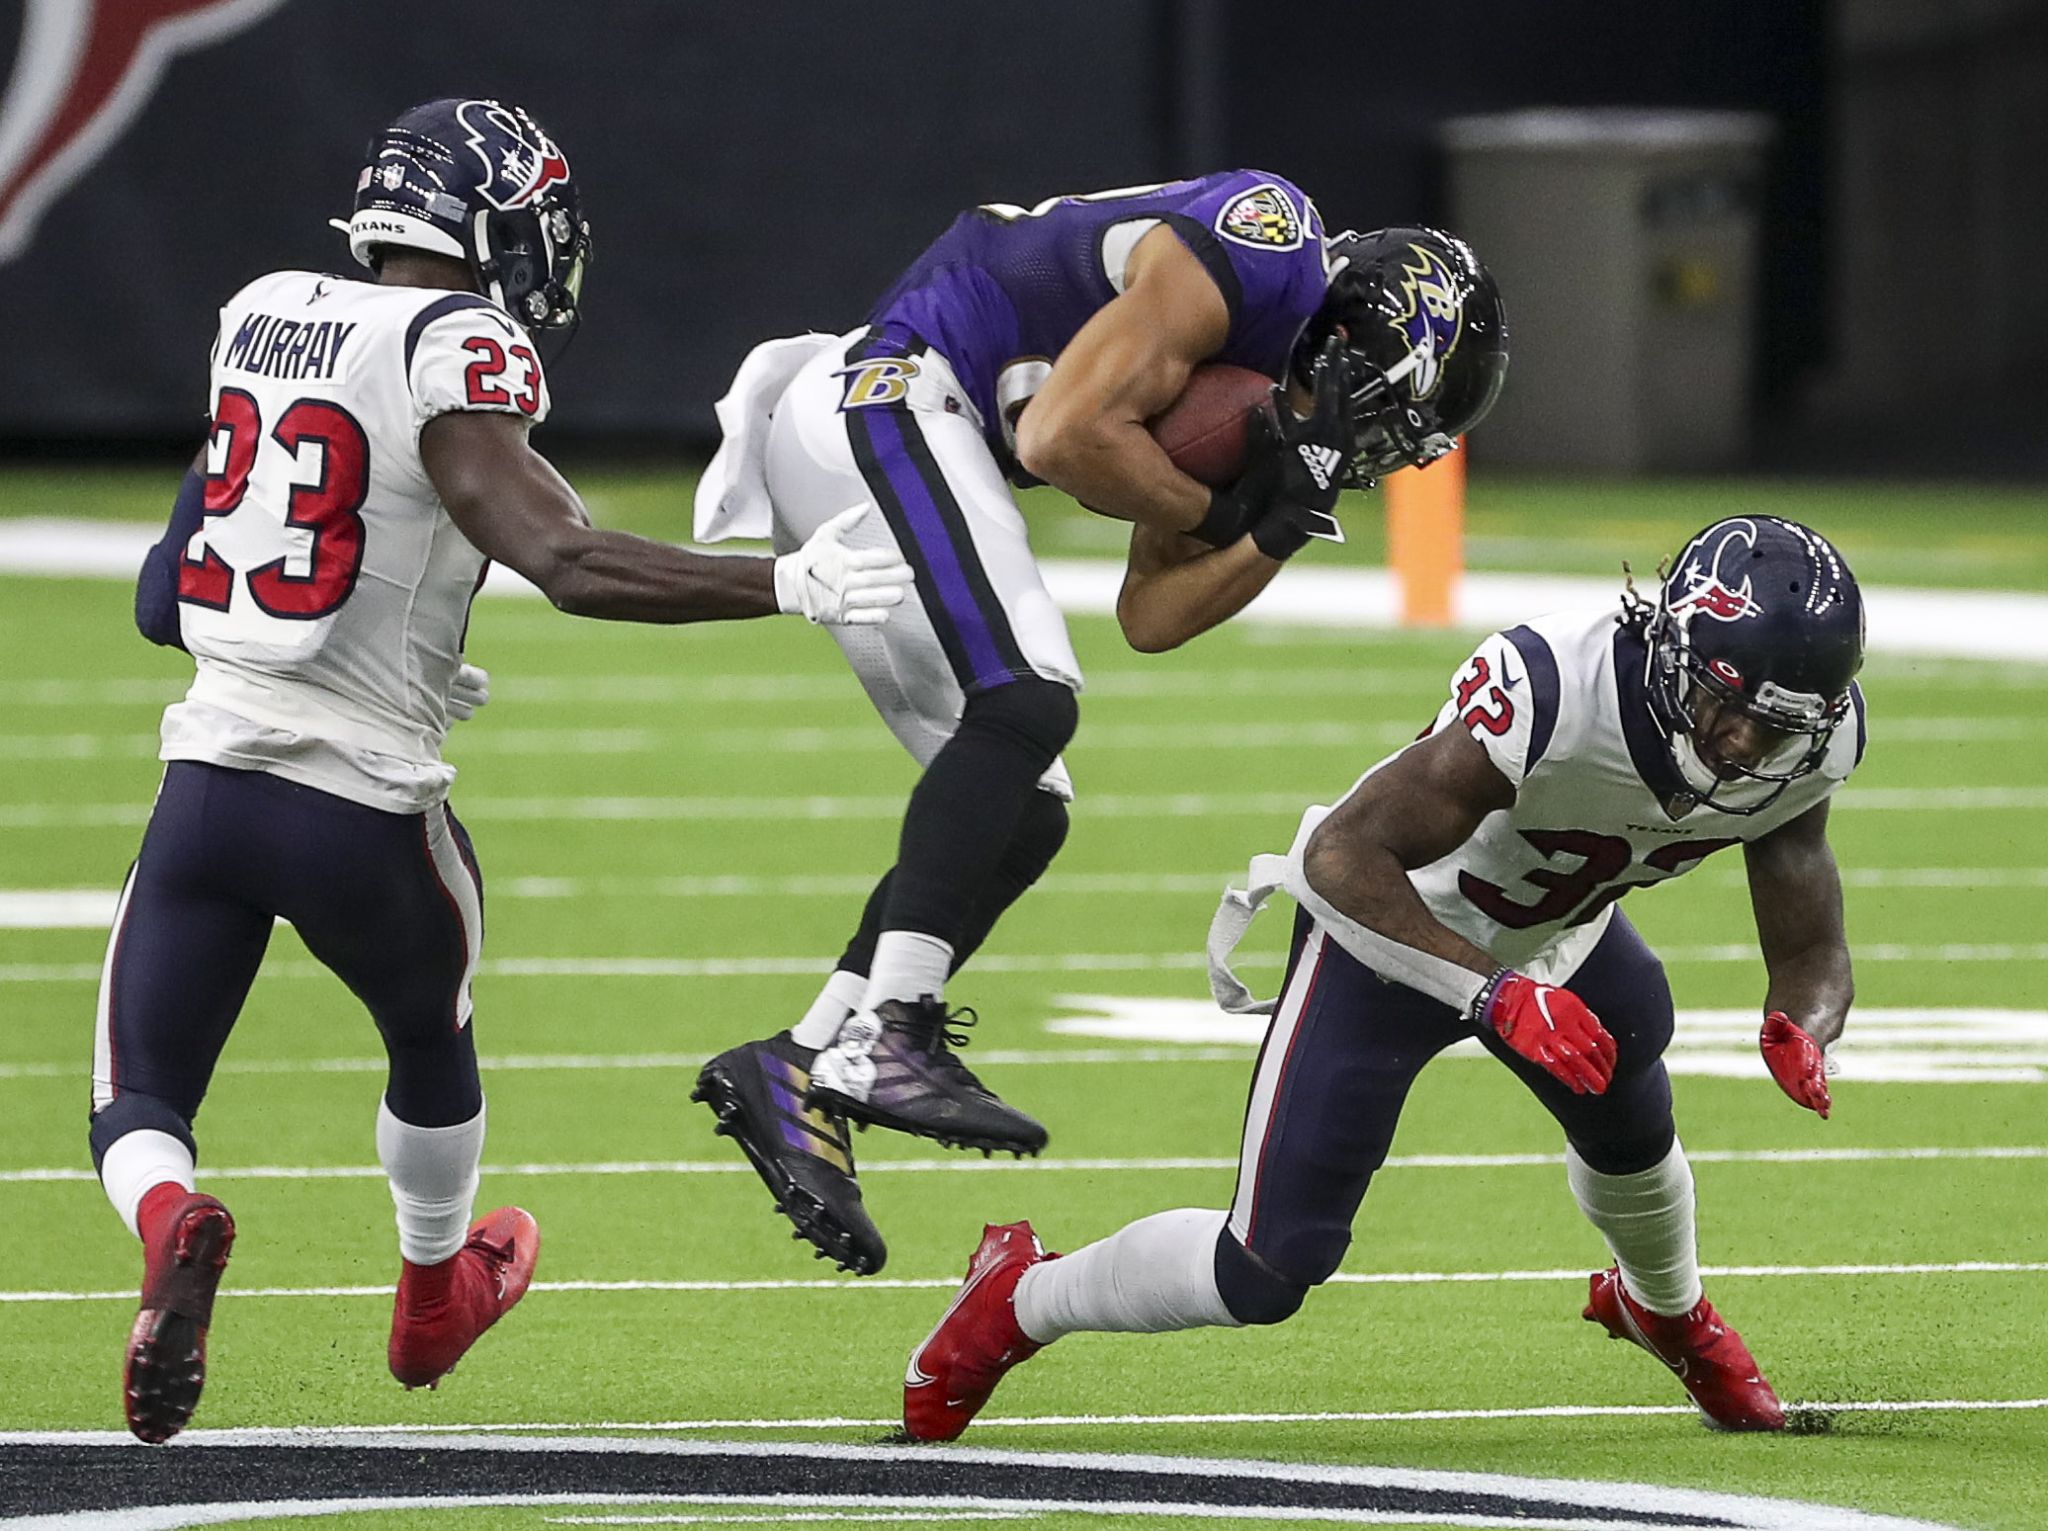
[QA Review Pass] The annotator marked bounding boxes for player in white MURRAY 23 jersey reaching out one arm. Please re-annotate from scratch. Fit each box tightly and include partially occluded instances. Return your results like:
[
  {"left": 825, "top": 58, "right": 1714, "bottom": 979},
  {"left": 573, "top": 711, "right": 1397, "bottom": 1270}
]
[{"left": 92, "top": 100, "right": 909, "bottom": 1441}]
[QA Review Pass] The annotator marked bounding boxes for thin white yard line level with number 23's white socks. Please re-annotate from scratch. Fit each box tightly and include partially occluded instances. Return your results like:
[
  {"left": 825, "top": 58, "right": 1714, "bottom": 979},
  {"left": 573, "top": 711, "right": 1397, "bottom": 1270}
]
[{"left": 0, "top": 1146, "right": 2048, "bottom": 1185}]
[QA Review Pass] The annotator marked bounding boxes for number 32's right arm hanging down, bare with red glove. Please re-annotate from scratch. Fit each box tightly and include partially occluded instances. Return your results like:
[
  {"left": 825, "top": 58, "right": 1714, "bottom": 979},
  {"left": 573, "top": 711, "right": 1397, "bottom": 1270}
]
[{"left": 1743, "top": 802, "right": 1855, "bottom": 1118}]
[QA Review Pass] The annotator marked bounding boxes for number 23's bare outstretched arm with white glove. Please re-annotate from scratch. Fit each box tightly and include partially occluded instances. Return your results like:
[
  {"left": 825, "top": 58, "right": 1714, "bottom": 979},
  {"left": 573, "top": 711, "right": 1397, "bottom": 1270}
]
[{"left": 420, "top": 411, "right": 911, "bottom": 624}]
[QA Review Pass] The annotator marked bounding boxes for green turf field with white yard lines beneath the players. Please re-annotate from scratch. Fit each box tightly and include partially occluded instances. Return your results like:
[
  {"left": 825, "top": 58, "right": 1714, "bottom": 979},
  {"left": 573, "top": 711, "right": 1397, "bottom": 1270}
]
[{"left": 0, "top": 473, "right": 2048, "bottom": 1531}]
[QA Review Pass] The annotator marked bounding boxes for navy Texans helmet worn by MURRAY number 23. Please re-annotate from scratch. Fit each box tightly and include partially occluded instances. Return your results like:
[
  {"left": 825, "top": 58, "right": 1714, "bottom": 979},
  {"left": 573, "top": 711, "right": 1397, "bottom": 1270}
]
[{"left": 334, "top": 96, "right": 590, "bottom": 330}]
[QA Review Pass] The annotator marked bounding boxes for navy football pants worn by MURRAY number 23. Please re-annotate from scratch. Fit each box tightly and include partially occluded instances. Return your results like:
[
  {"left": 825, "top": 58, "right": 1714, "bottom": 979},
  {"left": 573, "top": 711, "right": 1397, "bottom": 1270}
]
[{"left": 92, "top": 761, "right": 483, "bottom": 1165}]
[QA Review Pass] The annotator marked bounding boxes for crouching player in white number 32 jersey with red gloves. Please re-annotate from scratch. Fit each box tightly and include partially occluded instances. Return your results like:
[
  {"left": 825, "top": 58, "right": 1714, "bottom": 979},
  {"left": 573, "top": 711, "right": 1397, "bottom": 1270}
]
[{"left": 903, "top": 518, "right": 1866, "bottom": 1441}]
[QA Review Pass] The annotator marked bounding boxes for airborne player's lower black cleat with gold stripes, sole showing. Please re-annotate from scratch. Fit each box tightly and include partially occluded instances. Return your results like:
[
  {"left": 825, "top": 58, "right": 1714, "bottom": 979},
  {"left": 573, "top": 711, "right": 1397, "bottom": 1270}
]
[{"left": 690, "top": 1032, "right": 889, "bottom": 1275}]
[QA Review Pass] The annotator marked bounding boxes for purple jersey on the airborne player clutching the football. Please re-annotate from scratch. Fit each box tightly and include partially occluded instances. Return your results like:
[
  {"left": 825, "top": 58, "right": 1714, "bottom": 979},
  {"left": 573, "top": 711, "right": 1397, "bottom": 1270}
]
[{"left": 868, "top": 170, "right": 1327, "bottom": 446}]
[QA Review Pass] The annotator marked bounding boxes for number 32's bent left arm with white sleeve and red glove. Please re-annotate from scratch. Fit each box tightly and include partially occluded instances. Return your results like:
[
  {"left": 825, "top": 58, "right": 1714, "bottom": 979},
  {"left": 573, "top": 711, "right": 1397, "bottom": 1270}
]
[{"left": 1300, "top": 727, "right": 1616, "bottom": 1095}]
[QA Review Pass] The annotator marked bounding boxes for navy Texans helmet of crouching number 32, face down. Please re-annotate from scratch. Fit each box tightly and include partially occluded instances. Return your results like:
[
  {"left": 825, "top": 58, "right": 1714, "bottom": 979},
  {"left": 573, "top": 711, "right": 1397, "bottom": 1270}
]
[{"left": 1640, "top": 516, "right": 1864, "bottom": 815}]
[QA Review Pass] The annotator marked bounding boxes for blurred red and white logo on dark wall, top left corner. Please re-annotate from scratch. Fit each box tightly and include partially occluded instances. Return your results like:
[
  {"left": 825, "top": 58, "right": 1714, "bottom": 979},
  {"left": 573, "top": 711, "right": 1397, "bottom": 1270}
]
[{"left": 0, "top": 0, "right": 285, "bottom": 262}]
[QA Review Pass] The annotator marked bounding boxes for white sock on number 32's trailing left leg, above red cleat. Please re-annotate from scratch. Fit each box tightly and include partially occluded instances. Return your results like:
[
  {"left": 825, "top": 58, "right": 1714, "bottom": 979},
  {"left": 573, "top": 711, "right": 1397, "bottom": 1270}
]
[{"left": 1014, "top": 1208, "right": 1241, "bottom": 1345}]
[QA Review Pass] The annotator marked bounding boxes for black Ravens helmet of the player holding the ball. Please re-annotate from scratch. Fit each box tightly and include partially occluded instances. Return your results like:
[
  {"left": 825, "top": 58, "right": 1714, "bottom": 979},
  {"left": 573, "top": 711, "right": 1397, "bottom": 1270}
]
[{"left": 1290, "top": 229, "right": 1507, "bottom": 487}]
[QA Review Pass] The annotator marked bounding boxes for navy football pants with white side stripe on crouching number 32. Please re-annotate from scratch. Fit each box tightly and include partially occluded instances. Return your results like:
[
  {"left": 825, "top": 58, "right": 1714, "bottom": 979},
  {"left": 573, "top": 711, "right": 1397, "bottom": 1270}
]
[{"left": 1219, "top": 909, "right": 1675, "bottom": 1310}]
